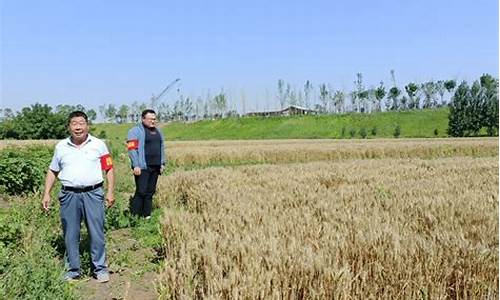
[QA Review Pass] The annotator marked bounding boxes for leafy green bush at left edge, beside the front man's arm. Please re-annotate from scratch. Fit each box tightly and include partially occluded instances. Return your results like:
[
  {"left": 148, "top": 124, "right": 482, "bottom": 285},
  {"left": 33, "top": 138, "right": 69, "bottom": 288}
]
[{"left": 0, "top": 146, "right": 53, "bottom": 195}]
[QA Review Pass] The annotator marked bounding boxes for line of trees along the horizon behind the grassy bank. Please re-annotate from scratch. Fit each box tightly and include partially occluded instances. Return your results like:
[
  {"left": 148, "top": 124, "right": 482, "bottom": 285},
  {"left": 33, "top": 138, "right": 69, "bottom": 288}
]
[{"left": 0, "top": 71, "right": 498, "bottom": 139}]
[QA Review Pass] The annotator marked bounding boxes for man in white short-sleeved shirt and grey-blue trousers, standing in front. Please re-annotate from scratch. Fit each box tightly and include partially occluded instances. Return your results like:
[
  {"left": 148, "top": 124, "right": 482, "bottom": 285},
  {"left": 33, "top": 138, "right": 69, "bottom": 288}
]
[{"left": 42, "top": 111, "right": 114, "bottom": 282}]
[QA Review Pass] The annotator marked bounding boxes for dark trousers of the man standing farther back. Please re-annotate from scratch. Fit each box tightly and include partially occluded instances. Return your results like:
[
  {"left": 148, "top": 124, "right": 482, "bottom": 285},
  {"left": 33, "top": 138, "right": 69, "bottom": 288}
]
[{"left": 131, "top": 167, "right": 160, "bottom": 217}]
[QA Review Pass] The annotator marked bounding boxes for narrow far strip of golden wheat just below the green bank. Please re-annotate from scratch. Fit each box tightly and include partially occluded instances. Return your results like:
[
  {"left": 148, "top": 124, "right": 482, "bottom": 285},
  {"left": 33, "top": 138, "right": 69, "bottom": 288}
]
[{"left": 167, "top": 138, "right": 498, "bottom": 167}]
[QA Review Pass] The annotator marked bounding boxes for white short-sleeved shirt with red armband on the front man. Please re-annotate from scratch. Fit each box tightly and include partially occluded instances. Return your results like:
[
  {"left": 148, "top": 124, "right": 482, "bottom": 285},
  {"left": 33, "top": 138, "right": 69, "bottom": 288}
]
[{"left": 49, "top": 134, "right": 111, "bottom": 187}]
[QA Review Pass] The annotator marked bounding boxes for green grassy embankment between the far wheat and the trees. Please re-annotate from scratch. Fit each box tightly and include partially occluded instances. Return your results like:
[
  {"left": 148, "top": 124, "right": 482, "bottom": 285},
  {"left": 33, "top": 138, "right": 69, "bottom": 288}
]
[{"left": 94, "top": 108, "right": 449, "bottom": 141}]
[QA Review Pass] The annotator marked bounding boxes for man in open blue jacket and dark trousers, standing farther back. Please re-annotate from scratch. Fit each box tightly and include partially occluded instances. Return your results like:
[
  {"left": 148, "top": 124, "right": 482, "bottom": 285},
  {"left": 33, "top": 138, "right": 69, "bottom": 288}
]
[{"left": 127, "top": 109, "right": 165, "bottom": 219}]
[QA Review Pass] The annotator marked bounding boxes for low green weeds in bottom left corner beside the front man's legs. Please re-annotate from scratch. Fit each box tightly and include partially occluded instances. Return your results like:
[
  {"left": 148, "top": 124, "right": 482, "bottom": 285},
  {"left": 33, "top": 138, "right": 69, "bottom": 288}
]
[{"left": 0, "top": 194, "right": 76, "bottom": 299}]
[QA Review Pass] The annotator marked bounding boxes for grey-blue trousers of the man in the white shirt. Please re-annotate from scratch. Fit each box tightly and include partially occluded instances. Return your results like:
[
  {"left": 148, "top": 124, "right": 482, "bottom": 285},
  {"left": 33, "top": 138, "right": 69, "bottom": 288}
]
[{"left": 59, "top": 187, "right": 107, "bottom": 274}]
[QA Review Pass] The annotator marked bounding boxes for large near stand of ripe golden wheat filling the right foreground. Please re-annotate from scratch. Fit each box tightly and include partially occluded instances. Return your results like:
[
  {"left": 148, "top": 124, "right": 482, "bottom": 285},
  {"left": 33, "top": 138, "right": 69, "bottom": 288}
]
[{"left": 158, "top": 156, "right": 498, "bottom": 299}]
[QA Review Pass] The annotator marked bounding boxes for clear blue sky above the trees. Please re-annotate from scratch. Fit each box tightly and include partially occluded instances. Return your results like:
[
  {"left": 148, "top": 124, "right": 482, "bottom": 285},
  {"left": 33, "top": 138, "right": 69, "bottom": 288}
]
[{"left": 0, "top": 0, "right": 499, "bottom": 110}]
